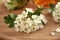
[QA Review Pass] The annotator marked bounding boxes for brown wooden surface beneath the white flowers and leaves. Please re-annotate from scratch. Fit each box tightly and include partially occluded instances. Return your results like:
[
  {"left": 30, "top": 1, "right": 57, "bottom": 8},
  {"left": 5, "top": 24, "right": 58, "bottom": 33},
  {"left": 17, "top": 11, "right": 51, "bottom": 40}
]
[{"left": 0, "top": 0, "right": 60, "bottom": 40}]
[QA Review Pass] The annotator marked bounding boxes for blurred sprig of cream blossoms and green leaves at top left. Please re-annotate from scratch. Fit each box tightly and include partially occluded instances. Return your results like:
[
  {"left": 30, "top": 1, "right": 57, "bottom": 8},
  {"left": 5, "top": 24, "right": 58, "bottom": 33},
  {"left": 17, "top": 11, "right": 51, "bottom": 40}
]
[{"left": 3, "top": 0, "right": 29, "bottom": 11}]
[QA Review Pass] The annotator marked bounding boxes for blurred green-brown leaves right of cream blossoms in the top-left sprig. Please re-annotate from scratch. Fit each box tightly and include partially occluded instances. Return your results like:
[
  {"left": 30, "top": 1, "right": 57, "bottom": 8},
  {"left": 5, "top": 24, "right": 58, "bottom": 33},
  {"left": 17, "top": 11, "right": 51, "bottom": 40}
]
[{"left": 8, "top": 0, "right": 30, "bottom": 11}]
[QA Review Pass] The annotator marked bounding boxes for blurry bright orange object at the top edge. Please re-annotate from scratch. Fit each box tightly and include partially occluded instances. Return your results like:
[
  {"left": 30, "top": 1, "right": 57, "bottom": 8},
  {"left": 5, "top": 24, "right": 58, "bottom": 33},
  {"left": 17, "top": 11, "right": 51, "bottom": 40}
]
[{"left": 34, "top": 0, "right": 57, "bottom": 8}]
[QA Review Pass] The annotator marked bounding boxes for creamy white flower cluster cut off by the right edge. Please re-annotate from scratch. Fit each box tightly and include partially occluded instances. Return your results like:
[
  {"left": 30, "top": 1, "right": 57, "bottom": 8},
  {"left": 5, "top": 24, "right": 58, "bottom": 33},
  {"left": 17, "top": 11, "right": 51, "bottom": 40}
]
[{"left": 52, "top": 2, "right": 60, "bottom": 22}]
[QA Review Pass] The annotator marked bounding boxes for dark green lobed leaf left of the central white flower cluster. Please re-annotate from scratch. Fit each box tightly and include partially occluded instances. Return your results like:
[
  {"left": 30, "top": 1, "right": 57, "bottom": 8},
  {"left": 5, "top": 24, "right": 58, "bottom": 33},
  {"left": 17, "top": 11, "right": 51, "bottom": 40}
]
[{"left": 4, "top": 13, "right": 17, "bottom": 28}]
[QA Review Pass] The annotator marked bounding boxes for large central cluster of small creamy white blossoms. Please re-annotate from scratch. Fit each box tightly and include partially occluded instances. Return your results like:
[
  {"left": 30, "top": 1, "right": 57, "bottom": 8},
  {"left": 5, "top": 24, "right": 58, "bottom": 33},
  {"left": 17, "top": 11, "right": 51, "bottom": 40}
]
[{"left": 14, "top": 8, "right": 47, "bottom": 33}]
